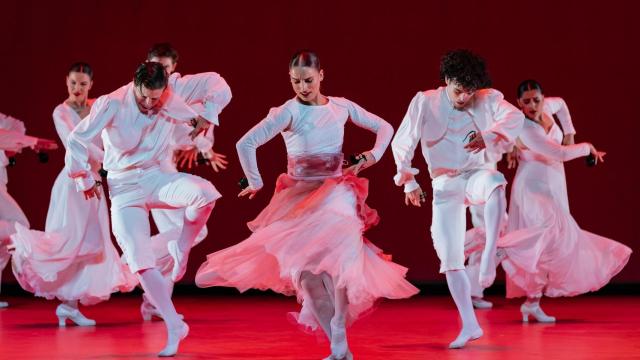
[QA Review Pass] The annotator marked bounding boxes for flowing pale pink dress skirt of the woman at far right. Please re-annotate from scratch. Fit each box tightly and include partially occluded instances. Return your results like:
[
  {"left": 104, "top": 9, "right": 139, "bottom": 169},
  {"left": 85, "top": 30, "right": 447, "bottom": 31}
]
[{"left": 498, "top": 125, "right": 631, "bottom": 297}]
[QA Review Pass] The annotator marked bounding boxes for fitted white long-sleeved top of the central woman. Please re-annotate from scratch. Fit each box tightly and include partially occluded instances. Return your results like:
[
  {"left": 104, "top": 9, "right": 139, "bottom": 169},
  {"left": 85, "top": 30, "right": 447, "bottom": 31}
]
[{"left": 236, "top": 97, "right": 393, "bottom": 190}]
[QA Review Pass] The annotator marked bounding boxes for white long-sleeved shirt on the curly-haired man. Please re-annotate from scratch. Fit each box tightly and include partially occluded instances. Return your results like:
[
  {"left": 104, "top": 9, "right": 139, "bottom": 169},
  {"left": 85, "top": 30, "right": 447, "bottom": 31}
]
[{"left": 391, "top": 87, "right": 524, "bottom": 192}]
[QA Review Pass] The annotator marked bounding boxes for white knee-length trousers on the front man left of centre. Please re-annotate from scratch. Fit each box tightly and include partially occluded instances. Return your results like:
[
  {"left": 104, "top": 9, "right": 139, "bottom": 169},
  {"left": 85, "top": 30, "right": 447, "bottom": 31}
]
[{"left": 108, "top": 166, "right": 221, "bottom": 273}]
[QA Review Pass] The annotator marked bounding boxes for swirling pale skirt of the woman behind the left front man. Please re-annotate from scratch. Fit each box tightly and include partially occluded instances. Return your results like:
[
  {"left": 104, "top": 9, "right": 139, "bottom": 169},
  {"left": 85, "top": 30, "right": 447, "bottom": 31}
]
[{"left": 11, "top": 170, "right": 137, "bottom": 305}]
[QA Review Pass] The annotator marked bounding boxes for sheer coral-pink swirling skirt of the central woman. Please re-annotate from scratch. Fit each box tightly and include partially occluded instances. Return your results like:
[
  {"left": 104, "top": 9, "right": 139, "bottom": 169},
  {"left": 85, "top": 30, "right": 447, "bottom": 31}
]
[{"left": 196, "top": 174, "right": 418, "bottom": 329}]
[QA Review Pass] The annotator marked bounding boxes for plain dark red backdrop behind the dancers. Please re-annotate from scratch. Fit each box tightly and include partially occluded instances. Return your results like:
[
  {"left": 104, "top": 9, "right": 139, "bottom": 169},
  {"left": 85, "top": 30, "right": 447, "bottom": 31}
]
[{"left": 0, "top": 0, "right": 640, "bottom": 282}]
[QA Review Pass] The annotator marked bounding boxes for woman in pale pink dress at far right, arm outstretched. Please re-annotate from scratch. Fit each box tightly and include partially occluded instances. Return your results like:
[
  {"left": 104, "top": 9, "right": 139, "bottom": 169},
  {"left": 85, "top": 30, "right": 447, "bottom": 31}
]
[{"left": 500, "top": 80, "right": 631, "bottom": 322}]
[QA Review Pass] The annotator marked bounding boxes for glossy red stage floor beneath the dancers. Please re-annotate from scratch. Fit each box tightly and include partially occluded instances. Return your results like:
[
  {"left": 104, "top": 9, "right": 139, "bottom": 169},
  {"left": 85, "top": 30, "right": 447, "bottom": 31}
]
[{"left": 0, "top": 295, "right": 640, "bottom": 360}]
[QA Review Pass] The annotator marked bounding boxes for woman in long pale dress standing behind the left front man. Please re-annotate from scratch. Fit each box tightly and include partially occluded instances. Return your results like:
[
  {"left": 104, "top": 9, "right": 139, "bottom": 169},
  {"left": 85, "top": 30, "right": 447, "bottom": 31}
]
[{"left": 11, "top": 62, "right": 137, "bottom": 326}]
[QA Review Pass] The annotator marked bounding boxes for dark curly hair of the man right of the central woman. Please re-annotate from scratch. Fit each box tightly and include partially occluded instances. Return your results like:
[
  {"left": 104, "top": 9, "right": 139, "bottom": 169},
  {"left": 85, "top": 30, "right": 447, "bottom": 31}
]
[{"left": 440, "top": 49, "right": 491, "bottom": 90}]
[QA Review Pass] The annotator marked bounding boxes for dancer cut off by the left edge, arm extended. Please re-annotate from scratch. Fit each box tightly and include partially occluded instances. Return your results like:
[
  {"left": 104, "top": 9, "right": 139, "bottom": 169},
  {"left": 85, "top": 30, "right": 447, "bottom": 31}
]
[{"left": 0, "top": 113, "right": 58, "bottom": 308}]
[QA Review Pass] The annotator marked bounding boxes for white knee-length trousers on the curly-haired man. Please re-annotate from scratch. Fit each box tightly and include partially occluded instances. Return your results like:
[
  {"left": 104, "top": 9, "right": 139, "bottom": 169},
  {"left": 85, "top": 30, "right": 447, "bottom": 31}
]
[{"left": 431, "top": 169, "right": 507, "bottom": 273}]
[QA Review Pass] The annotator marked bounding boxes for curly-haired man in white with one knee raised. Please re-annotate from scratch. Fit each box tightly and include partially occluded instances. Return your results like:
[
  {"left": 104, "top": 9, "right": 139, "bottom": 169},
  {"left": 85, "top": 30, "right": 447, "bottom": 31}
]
[{"left": 391, "top": 50, "right": 523, "bottom": 348}]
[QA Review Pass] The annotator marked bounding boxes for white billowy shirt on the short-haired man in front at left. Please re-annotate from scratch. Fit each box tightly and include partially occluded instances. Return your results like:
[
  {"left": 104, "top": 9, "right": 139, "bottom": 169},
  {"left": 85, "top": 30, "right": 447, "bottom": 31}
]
[{"left": 65, "top": 83, "right": 213, "bottom": 191}]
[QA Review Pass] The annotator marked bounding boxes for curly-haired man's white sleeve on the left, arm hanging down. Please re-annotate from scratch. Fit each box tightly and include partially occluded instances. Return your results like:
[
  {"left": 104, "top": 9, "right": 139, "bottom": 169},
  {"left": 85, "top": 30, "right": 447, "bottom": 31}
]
[{"left": 391, "top": 93, "right": 424, "bottom": 192}]
